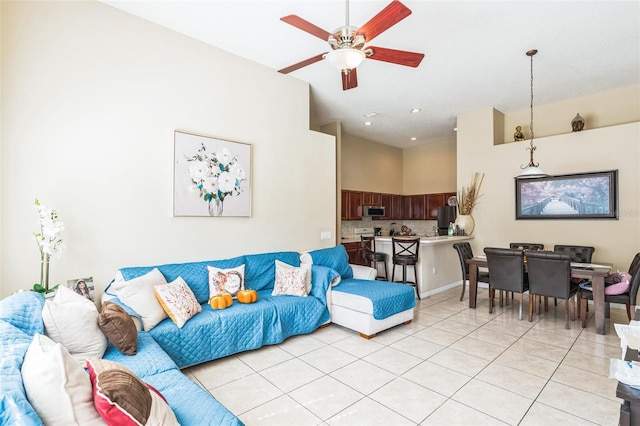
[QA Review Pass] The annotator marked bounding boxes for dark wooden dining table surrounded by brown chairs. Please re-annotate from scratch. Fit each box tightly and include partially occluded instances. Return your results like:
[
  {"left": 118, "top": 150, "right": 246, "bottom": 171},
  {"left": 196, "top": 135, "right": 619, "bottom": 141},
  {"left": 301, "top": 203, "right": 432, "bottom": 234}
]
[{"left": 467, "top": 256, "right": 611, "bottom": 334}]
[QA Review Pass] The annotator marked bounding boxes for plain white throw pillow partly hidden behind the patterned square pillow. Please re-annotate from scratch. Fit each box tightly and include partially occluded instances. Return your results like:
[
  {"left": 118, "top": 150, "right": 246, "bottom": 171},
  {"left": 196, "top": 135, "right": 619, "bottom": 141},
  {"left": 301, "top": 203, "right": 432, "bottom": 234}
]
[{"left": 115, "top": 268, "right": 167, "bottom": 331}]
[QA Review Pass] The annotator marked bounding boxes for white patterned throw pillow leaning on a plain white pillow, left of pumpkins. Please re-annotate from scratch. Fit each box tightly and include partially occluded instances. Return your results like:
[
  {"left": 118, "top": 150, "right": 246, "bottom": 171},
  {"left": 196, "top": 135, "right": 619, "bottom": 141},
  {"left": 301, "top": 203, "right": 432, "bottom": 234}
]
[{"left": 155, "top": 277, "right": 202, "bottom": 328}]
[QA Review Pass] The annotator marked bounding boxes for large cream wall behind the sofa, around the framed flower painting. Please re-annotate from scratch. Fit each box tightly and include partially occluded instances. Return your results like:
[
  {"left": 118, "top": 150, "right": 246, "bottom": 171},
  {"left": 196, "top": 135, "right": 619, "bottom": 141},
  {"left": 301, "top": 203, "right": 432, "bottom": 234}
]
[{"left": 0, "top": 1, "right": 336, "bottom": 297}]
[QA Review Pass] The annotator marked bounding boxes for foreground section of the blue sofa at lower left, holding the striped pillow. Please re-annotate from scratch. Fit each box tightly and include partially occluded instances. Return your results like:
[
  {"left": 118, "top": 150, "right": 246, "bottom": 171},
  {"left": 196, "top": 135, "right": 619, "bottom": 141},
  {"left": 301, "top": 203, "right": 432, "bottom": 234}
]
[{"left": 0, "top": 292, "right": 242, "bottom": 426}]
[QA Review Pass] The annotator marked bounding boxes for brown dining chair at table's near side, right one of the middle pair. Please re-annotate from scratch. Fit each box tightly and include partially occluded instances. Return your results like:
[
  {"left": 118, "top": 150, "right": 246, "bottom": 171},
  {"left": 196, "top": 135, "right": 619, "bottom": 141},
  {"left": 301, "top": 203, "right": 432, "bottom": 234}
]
[{"left": 524, "top": 251, "right": 580, "bottom": 330}]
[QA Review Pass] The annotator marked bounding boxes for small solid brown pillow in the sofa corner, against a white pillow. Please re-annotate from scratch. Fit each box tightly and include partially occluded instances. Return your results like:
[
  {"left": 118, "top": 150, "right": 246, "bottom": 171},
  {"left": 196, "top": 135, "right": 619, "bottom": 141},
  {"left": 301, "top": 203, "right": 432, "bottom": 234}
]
[{"left": 98, "top": 302, "right": 138, "bottom": 355}]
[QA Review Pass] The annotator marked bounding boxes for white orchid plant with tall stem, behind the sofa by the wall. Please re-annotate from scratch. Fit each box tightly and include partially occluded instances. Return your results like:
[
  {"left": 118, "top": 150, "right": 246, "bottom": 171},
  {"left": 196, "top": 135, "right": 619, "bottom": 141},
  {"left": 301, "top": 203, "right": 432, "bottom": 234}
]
[{"left": 33, "top": 198, "right": 64, "bottom": 294}]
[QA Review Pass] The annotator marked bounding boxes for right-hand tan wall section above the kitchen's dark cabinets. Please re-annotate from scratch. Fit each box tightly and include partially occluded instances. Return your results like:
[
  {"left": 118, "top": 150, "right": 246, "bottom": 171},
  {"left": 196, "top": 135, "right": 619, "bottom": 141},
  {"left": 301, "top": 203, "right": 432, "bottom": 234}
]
[{"left": 402, "top": 140, "right": 456, "bottom": 195}]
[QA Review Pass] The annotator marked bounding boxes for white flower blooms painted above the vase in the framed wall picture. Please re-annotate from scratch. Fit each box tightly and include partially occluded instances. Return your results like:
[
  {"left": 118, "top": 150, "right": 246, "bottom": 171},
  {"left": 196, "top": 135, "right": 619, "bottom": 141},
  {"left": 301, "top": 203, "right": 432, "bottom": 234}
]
[{"left": 187, "top": 143, "right": 246, "bottom": 207}]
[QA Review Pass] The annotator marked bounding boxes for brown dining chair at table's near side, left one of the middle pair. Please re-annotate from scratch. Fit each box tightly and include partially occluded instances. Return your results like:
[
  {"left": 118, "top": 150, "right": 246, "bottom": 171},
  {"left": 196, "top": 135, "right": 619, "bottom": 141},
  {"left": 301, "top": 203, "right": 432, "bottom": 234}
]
[{"left": 484, "top": 247, "right": 529, "bottom": 321}]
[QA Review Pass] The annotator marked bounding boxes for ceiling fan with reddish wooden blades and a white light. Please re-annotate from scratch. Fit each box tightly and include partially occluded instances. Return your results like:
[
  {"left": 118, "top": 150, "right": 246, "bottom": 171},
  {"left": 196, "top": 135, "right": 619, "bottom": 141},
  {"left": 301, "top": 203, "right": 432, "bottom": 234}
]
[{"left": 278, "top": 0, "right": 424, "bottom": 90}]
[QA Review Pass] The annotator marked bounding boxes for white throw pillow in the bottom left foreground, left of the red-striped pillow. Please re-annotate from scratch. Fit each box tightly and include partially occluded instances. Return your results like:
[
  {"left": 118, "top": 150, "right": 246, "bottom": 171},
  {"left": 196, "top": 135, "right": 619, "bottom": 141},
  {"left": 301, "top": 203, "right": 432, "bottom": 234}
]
[{"left": 21, "top": 334, "right": 106, "bottom": 426}]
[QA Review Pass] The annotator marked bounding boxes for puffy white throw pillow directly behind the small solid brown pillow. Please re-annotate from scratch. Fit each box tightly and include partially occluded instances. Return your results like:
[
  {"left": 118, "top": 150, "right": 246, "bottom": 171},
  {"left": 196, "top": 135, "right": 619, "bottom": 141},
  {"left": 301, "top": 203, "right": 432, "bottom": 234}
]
[{"left": 42, "top": 287, "right": 107, "bottom": 365}]
